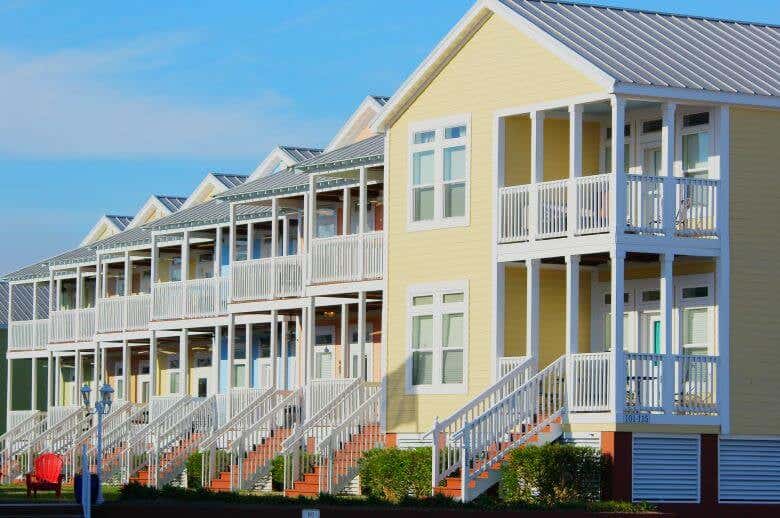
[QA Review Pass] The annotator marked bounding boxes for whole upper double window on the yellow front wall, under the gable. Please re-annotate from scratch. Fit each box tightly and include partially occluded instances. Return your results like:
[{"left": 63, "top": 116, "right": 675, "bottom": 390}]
[{"left": 409, "top": 117, "right": 469, "bottom": 233}]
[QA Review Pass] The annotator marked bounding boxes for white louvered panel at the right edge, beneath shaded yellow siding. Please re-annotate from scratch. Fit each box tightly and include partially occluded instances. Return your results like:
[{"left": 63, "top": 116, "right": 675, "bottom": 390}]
[{"left": 718, "top": 439, "right": 780, "bottom": 503}]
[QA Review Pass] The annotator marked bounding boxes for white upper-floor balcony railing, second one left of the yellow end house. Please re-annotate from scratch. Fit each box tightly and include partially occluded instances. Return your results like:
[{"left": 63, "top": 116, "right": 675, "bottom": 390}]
[{"left": 231, "top": 255, "right": 305, "bottom": 301}]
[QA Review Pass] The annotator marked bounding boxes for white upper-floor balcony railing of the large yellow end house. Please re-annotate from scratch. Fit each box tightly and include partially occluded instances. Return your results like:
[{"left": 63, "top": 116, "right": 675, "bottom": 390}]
[{"left": 497, "top": 174, "right": 719, "bottom": 243}]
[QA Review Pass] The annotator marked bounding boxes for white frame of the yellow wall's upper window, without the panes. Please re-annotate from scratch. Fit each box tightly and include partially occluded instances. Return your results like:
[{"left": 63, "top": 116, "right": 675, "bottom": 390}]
[{"left": 406, "top": 117, "right": 472, "bottom": 232}]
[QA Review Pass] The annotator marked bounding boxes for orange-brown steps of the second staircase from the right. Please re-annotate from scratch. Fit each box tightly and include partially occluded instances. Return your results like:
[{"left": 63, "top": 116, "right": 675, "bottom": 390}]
[{"left": 284, "top": 423, "right": 384, "bottom": 498}]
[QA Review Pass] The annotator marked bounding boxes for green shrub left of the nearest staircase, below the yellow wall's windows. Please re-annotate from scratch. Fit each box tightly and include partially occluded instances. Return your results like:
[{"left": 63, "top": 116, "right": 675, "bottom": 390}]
[{"left": 360, "top": 448, "right": 431, "bottom": 503}]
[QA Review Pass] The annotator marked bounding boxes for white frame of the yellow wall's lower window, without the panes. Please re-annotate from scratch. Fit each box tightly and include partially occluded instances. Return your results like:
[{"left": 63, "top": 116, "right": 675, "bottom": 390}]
[{"left": 406, "top": 281, "right": 469, "bottom": 394}]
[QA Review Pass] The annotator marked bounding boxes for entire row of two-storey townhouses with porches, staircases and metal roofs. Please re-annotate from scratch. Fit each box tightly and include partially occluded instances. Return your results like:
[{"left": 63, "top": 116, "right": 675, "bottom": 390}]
[{"left": 0, "top": 0, "right": 780, "bottom": 510}]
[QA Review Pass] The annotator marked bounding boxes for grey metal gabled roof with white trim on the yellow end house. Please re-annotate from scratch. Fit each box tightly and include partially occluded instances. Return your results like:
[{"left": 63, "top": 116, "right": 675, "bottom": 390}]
[{"left": 374, "top": 0, "right": 780, "bottom": 131}]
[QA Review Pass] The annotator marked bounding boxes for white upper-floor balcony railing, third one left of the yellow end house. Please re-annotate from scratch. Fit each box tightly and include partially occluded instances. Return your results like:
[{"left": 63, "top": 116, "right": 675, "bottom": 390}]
[{"left": 152, "top": 277, "right": 230, "bottom": 320}]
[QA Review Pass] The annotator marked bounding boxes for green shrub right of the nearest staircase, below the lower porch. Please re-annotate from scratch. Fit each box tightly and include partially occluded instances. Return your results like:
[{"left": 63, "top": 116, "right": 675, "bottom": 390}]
[{"left": 499, "top": 444, "right": 602, "bottom": 506}]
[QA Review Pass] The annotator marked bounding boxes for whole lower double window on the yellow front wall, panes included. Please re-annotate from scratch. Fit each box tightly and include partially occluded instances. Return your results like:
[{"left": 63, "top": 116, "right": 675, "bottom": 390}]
[{"left": 407, "top": 282, "right": 468, "bottom": 393}]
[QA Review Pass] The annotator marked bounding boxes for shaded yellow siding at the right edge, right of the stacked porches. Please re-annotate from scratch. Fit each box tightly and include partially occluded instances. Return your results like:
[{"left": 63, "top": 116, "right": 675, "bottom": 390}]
[{"left": 730, "top": 109, "right": 780, "bottom": 435}]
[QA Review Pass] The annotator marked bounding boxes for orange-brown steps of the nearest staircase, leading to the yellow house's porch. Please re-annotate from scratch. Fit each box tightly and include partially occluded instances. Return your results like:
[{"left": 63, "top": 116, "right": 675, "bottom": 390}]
[{"left": 433, "top": 416, "right": 562, "bottom": 500}]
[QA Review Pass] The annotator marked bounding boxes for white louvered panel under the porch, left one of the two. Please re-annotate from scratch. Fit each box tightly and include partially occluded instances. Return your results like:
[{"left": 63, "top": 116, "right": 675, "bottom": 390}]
[{"left": 632, "top": 434, "right": 700, "bottom": 502}]
